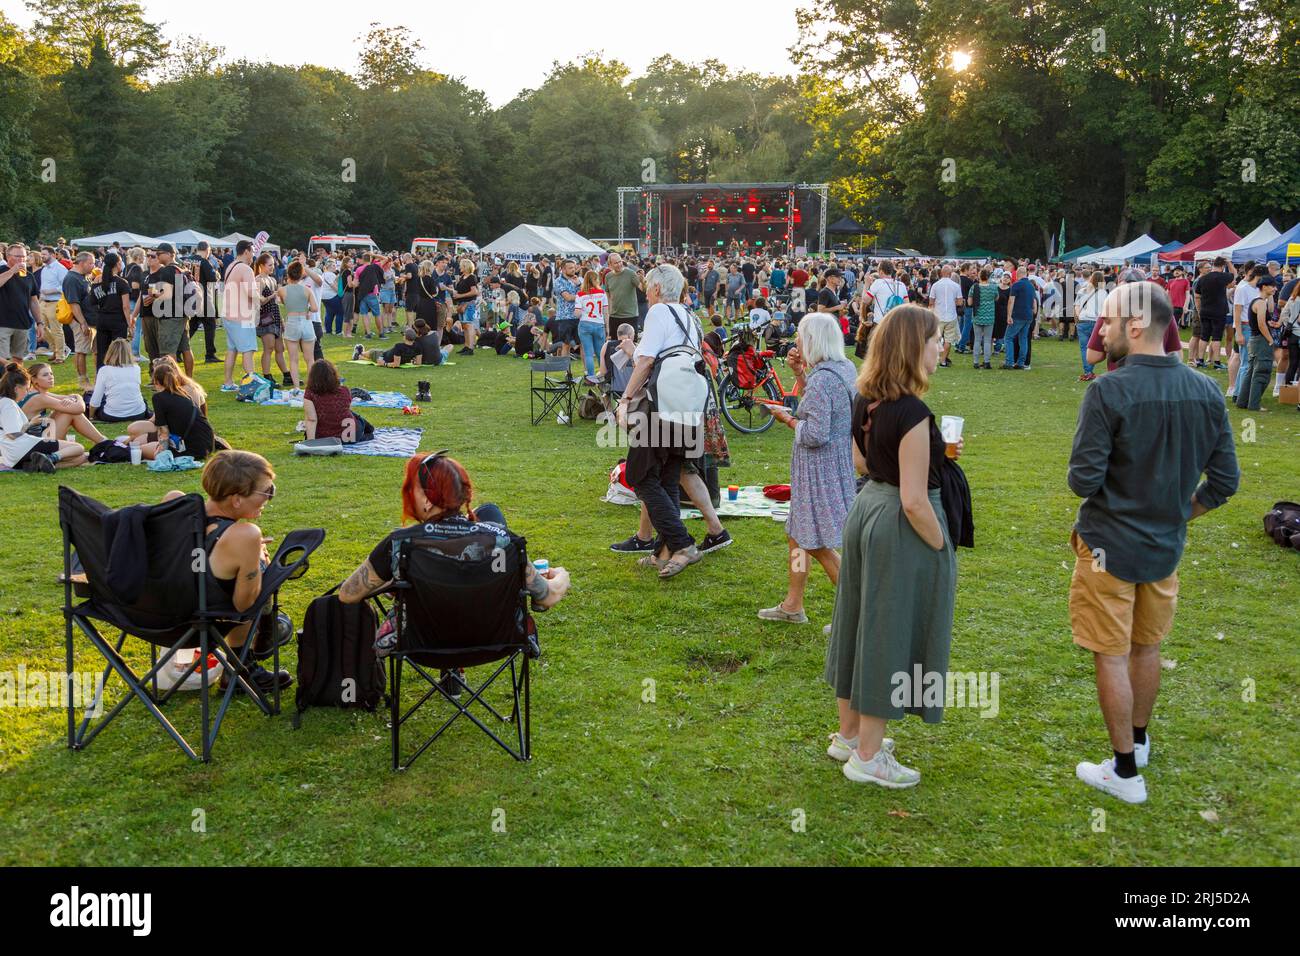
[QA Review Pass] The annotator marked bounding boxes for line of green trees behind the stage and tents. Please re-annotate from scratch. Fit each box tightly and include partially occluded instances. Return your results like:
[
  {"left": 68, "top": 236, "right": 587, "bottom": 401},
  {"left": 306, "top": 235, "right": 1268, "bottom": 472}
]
[{"left": 0, "top": 0, "right": 1300, "bottom": 254}]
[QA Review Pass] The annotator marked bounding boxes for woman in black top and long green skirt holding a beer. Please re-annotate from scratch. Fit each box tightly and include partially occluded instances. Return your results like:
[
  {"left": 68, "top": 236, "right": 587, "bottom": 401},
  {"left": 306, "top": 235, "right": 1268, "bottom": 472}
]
[{"left": 824, "top": 304, "right": 961, "bottom": 788}]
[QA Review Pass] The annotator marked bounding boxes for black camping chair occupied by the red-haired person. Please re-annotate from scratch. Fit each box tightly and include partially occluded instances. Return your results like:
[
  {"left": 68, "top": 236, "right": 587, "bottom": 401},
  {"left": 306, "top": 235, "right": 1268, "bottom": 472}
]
[{"left": 374, "top": 532, "right": 541, "bottom": 770}]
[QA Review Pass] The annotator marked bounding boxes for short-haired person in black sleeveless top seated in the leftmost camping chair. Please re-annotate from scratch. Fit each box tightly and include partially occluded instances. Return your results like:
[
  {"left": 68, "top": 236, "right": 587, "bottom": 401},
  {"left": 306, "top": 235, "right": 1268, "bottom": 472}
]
[{"left": 163, "top": 451, "right": 294, "bottom": 692}]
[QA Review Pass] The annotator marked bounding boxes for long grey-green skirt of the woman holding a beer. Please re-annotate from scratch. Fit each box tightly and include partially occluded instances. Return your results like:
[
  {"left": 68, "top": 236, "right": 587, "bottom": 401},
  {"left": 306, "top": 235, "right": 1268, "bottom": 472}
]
[{"left": 824, "top": 481, "right": 957, "bottom": 723}]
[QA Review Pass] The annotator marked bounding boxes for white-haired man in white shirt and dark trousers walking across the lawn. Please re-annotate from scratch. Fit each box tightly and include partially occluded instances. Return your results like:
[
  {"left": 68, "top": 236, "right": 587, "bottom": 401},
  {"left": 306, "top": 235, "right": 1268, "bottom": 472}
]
[{"left": 618, "top": 265, "right": 703, "bottom": 578}]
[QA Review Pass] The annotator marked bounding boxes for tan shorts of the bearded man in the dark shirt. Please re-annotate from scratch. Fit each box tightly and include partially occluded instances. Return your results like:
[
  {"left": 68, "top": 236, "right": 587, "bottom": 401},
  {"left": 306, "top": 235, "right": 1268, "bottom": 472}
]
[{"left": 1070, "top": 531, "right": 1178, "bottom": 657}]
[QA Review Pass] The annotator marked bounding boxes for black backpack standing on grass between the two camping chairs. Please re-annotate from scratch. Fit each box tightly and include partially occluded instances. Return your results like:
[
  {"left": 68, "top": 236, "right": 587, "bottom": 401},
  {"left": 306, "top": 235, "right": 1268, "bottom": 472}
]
[{"left": 294, "top": 588, "right": 387, "bottom": 730}]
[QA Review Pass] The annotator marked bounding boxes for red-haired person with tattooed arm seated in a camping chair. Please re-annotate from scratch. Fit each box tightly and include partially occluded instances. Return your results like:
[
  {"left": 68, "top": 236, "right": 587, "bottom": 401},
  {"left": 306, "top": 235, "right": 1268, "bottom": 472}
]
[{"left": 338, "top": 451, "right": 569, "bottom": 696}]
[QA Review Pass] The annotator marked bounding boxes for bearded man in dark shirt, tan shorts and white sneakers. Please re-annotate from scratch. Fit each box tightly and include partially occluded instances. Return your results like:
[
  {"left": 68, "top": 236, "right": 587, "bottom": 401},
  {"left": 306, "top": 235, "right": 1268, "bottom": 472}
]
[{"left": 1069, "top": 282, "right": 1240, "bottom": 804}]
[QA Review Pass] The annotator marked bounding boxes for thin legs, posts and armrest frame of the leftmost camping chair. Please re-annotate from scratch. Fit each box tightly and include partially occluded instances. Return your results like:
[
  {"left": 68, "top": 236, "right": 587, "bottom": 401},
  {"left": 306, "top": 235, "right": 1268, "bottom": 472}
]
[{"left": 62, "top": 494, "right": 325, "bottom": 763}]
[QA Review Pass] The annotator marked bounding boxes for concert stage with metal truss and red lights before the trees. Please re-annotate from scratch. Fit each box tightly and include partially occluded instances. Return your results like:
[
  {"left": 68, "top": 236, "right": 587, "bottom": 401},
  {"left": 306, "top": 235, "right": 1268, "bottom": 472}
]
[{"left": 619, "top": 182, "right": 827, "bottom": 256}]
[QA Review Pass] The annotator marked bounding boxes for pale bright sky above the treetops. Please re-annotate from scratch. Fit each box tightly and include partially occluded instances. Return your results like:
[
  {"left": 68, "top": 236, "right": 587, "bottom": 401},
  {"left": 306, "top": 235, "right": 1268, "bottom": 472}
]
[{"left": 0, "top": 0, "right": 798, "bottom": 107}]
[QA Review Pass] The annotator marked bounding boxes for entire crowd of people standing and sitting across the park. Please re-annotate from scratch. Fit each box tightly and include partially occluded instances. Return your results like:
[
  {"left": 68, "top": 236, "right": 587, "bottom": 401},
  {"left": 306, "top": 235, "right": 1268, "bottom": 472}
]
[{"left": 0, "top": 230, "right": 1258, "bottom": 803}]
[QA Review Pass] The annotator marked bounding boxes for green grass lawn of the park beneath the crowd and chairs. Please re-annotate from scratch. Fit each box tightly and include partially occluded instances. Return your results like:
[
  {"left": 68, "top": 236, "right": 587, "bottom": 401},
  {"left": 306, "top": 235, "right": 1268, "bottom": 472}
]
[{"left": 0, "top": 327, "right": 1300, "bottom": 865}]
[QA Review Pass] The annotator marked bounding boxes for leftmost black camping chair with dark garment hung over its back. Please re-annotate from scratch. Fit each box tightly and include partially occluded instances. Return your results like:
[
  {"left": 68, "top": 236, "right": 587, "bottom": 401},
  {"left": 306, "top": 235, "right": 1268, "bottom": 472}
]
[{"left": 59, "top": 485, "right": 325, "bottom": 762}]
